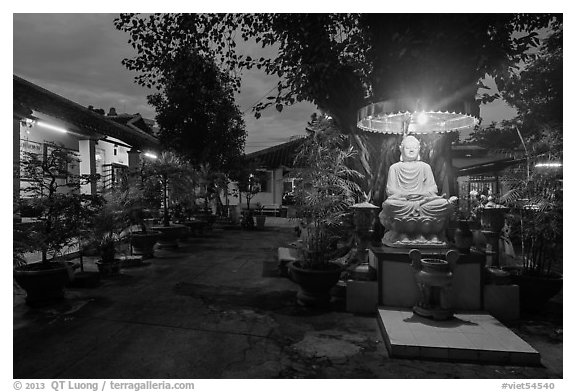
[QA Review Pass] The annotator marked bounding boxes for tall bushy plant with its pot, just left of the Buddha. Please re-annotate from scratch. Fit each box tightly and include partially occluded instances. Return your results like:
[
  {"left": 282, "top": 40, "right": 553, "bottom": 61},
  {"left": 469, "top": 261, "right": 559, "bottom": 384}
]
[{"left": 288, "top": 119, "right": 361, "bottom": 306}]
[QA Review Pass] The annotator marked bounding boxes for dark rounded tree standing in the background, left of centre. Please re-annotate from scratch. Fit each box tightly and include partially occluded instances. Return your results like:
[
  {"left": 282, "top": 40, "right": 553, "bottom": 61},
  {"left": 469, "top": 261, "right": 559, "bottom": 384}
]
[{"left": 148, "top": 50, "right": 246, "bottom": 168}]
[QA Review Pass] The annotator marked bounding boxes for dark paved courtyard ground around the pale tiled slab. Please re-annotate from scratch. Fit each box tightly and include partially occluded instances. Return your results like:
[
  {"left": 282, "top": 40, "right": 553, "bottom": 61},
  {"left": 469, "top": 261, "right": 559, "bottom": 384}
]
[{"left": 13, "top": 218, "right": 563, "bottom": 379}]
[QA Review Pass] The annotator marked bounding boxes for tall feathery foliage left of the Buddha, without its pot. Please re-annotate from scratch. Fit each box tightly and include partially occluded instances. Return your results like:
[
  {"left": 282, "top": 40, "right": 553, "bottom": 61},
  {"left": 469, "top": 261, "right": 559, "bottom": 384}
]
[{"left": 294, "top": 118, "right": 361, "bottom": 269}]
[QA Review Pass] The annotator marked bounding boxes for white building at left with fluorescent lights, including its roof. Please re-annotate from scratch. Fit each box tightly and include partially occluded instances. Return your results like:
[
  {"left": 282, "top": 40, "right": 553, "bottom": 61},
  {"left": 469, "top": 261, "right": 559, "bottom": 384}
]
[{"left": 13, "top": 75, "right": 160, "bottom": 219}]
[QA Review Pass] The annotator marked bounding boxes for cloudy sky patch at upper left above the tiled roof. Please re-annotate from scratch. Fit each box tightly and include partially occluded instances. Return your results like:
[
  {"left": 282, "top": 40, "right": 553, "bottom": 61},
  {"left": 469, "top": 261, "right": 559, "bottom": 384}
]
[{"left": 14, "top": 14, "right": 154, "bottom": 118}]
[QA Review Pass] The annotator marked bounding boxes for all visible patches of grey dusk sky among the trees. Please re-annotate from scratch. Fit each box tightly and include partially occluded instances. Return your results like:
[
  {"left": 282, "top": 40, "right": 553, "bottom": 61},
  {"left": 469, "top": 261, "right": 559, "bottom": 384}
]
[{"left": 13, "top": 13, "right": 513, "bottom": 153}]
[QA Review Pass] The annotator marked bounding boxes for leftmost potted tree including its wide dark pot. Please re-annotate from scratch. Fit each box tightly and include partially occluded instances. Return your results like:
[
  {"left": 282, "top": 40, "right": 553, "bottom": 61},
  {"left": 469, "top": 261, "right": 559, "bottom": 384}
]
[{"left": 14, "top": 145, "right": 101, "bottom": 306}]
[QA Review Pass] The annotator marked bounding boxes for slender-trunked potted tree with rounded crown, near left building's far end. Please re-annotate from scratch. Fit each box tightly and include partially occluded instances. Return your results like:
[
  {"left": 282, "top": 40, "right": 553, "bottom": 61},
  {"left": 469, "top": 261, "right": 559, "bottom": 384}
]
[{"left": 144, "top": 151, "right": 190, "bottom": 248}]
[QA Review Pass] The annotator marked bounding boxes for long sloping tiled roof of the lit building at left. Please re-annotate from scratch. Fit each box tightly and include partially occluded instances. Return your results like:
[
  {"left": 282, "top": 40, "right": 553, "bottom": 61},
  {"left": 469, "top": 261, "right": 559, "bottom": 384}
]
[{"left": 13, "top": 75, "right": 159, "bottom": 149}]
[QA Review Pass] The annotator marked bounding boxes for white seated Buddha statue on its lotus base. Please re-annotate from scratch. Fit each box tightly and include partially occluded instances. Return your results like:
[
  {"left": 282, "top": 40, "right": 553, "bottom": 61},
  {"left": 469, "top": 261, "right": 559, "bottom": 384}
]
[{"left": 380, "top": 136, "right": 453, "bottom": 247}]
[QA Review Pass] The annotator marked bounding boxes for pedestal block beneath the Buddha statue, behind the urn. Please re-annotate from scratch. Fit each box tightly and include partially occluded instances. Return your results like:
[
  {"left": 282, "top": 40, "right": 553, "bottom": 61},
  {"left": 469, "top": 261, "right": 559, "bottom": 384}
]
[{"left": 368, "top": 246, "right": 486, "bottom": 311}]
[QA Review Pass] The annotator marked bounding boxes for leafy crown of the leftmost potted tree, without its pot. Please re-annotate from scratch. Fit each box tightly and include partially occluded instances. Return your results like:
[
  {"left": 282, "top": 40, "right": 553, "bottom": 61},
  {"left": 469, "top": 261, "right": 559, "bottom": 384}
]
[{"left": 20, "top": 145, "right": 102, "bottom": 264}]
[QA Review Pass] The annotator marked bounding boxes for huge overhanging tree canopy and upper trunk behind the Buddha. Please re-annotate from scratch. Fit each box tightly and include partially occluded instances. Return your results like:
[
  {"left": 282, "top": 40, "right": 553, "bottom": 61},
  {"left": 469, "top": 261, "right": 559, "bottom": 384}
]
[{"left": 116, "top": 14, "right": 561, "bottom": 203}]
